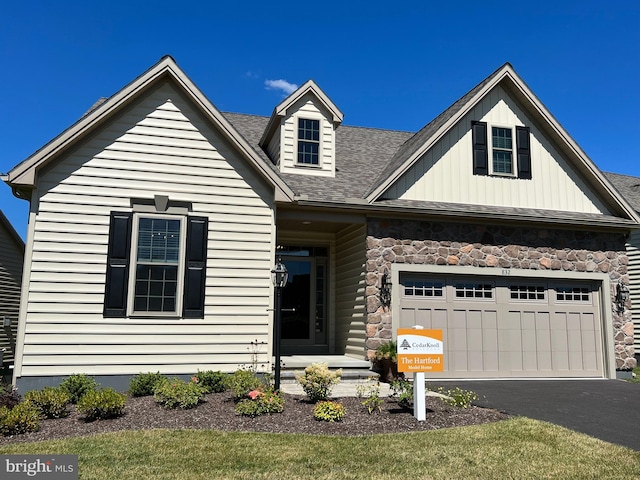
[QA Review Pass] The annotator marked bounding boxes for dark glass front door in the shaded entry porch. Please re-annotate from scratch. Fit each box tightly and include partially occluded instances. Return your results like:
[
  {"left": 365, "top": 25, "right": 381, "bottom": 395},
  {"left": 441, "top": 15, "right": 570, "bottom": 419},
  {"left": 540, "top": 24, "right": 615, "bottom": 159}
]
[{"left": 278, "top": 247, "right": 329, "bottom": 355}]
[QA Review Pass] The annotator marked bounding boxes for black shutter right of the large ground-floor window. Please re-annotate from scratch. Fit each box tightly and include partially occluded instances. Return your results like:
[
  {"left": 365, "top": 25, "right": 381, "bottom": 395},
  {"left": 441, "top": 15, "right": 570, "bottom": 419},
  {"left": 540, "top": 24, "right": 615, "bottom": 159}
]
[{"left": 182, "top": 217, "right": 209, "bottom": 318}]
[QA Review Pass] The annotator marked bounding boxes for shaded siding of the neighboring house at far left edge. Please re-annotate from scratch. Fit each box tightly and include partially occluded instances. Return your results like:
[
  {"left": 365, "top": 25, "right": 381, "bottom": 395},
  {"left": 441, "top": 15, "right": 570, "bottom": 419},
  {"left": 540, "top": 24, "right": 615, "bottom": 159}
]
[{"left": 0, "top": 214, "right": 24, "bottom": 366}]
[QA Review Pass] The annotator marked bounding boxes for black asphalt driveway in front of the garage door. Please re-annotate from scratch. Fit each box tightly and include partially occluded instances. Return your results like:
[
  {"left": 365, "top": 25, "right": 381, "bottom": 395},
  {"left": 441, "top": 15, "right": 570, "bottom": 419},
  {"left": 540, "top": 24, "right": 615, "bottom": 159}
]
[{"left": 427, "top": 380, "right": 640, "bottom": 451}]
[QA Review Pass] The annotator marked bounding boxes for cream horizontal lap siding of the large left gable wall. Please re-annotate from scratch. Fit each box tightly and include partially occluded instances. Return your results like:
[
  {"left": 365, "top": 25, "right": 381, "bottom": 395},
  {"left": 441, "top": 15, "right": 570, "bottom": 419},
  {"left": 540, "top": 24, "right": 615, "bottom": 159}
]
[{"left": 16, "top": 83, "right": 275, "bottom": 377}]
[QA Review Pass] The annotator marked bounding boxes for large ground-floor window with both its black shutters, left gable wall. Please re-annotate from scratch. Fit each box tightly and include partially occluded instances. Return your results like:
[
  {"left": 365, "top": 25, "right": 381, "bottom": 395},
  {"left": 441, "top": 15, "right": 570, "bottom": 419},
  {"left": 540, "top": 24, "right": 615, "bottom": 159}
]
[{"left": 104, "top": 212, "right": 208, "bottom": 318}]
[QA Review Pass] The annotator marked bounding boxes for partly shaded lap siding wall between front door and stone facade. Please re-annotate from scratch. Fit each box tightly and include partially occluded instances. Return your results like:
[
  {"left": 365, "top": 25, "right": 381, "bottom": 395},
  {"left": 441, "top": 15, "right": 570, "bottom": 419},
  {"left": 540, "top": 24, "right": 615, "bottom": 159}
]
[{"left": 336, "top": 225, "right": 367, "bottom": 359}]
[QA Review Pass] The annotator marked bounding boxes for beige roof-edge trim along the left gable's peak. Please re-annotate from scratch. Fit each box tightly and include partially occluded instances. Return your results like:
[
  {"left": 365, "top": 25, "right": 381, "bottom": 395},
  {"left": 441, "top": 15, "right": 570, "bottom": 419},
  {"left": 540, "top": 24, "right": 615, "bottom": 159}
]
[{"left": 3, "top": 56, "right": 293, "bottom": 200}]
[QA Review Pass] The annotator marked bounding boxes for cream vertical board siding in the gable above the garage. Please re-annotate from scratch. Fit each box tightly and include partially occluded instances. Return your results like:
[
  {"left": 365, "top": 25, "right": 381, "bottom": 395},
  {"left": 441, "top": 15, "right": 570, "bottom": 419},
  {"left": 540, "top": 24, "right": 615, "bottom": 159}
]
[{"left": 385, "top": 86, "right": 610, "bottom": 214}]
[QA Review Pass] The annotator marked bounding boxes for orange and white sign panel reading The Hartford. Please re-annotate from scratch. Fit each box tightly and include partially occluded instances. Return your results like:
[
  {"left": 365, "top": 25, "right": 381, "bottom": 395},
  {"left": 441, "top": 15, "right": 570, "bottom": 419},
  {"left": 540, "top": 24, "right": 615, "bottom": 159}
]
[{"left": 397, "top": 328, "right": 444, "bottom": 373}]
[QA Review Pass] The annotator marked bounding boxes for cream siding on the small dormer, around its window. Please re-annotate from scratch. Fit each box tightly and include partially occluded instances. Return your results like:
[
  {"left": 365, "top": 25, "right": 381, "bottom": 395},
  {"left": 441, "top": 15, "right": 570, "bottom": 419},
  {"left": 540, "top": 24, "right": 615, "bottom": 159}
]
[{"left": 280, "top": 95, "right": 335, "bottom": 177}]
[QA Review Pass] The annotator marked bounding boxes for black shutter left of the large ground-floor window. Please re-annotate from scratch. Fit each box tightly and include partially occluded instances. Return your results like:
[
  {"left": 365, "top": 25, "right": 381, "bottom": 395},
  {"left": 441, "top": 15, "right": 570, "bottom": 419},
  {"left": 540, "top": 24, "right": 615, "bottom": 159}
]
[{"left": 103, "top": 212, "right": 133, "bottom": 317}]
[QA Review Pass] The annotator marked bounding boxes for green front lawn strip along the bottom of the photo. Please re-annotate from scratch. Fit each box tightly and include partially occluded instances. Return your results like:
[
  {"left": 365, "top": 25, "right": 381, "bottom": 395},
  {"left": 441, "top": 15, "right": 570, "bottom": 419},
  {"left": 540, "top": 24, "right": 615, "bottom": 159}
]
[{"left": 0, "top": 418, "right": 640, "bottom": 480}]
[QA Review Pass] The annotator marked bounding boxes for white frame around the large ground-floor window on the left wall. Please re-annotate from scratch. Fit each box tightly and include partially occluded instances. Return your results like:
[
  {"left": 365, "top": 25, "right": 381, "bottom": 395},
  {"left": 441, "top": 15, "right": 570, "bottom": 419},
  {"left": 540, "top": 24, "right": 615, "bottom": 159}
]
[{"left": 127, "top": 212, "right": 187, "bottom": 318}]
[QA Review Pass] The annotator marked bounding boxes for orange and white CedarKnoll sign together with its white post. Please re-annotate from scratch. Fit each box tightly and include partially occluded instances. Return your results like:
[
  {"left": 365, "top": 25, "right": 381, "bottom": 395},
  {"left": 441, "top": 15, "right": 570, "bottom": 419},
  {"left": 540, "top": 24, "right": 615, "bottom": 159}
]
[{"left": 397, "top": 325, "right": 444, "bottom": 421}]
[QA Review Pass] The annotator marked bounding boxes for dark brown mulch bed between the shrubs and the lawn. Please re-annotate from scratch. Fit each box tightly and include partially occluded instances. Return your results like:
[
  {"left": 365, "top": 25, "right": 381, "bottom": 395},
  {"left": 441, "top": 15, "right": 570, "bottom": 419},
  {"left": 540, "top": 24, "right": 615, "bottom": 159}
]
[{"left": 0, "top": 392, "right": 508, "bottom": 445}]
